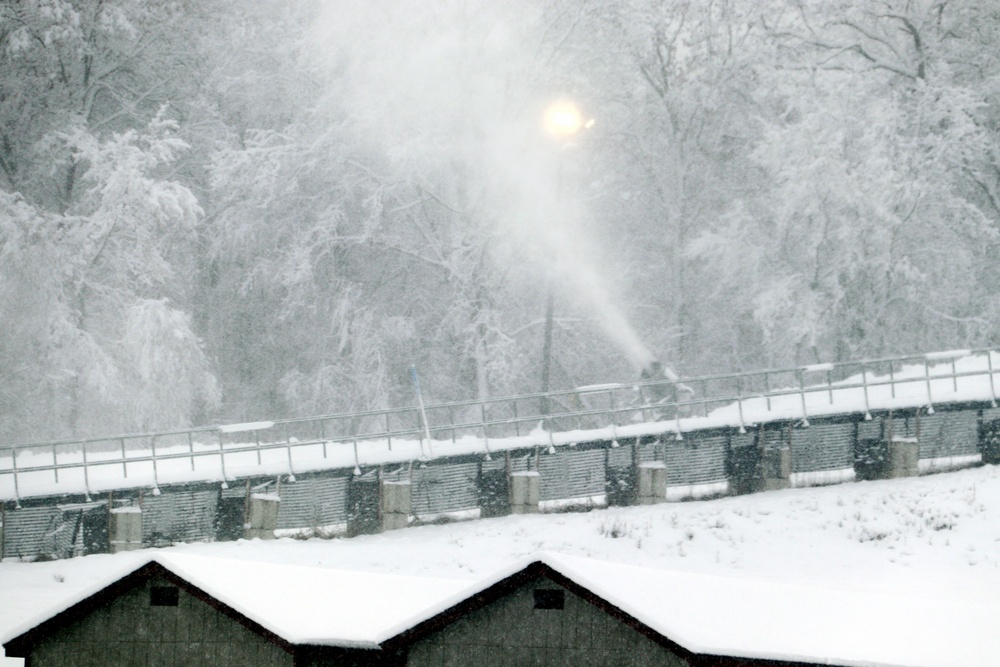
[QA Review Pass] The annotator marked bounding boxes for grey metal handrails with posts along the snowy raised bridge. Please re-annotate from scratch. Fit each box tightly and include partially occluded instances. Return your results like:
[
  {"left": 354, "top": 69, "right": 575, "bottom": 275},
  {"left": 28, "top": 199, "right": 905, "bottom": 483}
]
[{"left": 0, "top": 349, "right": 996, "bottom": 499}]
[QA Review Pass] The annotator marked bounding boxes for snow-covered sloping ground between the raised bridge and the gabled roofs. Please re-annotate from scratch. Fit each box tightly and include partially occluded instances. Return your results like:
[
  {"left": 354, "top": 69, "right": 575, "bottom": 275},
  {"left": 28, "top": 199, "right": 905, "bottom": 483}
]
[{"left": 0, "top": 466, "right": 1000, "bottom": 667}]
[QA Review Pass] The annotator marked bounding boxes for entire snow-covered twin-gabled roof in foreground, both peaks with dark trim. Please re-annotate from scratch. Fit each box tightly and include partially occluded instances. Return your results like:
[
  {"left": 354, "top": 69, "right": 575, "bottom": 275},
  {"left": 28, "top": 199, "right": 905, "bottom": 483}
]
[{"left": 5, "top": 553, "right": 1000, "bottom": 667}]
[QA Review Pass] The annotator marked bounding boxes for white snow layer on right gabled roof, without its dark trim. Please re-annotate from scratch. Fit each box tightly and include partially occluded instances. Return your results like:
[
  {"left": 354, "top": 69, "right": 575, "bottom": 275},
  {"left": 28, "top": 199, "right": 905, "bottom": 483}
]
[{"left": 382, "top": 553, "right": 1000, "bottom": 667}]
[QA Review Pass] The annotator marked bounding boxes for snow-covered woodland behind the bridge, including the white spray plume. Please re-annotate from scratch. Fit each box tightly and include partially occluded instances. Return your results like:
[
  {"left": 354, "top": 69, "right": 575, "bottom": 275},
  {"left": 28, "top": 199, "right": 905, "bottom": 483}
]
[{"left": 0, "top": 0, "right": 1000, "bottom": 441}]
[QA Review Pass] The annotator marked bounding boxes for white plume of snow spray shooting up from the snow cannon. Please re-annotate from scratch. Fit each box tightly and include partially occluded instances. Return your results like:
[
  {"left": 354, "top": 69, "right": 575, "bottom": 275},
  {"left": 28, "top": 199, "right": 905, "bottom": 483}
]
[{"left": 315, "top": 0, "right": 656, "bottom": 373}]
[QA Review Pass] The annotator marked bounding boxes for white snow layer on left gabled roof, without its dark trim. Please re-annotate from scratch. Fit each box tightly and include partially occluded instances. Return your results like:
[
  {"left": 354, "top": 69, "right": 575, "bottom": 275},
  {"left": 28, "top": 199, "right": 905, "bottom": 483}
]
[{"left": 5, "top": 554, "right": 468, "bottom": 648}]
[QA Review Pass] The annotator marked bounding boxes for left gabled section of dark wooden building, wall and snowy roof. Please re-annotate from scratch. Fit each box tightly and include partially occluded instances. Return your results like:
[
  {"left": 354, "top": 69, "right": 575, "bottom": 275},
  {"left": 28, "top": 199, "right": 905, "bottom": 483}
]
[{"left": 4, "top": 555, "right": 468, "bottom": 667}]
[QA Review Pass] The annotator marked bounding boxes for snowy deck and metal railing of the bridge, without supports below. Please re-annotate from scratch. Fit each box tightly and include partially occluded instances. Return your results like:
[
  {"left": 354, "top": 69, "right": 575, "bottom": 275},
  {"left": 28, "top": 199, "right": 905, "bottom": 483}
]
[{"left": 0, "top": 349, "right": 1000, "bottom": 500}]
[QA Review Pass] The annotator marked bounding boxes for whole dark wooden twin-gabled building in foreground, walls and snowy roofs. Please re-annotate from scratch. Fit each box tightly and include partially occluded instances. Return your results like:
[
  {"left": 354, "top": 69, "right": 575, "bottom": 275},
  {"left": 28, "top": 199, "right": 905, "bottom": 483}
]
[{"left": 4, "top": 554, "right": 984, "bottom": 667}]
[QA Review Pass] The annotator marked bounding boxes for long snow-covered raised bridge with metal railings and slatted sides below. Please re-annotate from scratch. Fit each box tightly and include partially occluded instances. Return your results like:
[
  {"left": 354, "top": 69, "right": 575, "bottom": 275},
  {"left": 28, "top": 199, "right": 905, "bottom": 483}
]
[{"left": 0, "top": 350, "right": 1000, "bottom": 556}]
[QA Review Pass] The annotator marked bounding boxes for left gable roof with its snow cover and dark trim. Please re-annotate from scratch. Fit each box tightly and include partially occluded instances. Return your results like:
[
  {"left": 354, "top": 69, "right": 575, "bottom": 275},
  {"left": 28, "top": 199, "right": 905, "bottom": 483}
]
[{"left": 5, "top": 554, "right": 468, "bottom": 655}]
